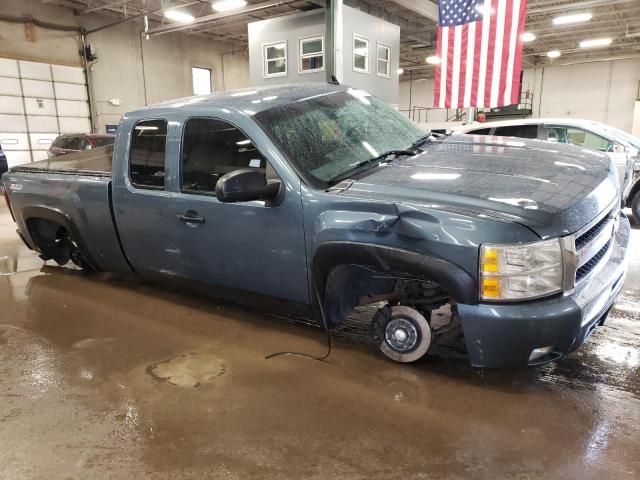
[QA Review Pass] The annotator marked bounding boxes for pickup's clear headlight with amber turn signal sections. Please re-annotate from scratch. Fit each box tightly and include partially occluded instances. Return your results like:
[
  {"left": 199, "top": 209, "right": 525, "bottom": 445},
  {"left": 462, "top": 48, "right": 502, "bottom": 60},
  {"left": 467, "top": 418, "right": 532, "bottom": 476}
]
[{"left": 480, "top": 238, "right": 563, "bottom": 301}]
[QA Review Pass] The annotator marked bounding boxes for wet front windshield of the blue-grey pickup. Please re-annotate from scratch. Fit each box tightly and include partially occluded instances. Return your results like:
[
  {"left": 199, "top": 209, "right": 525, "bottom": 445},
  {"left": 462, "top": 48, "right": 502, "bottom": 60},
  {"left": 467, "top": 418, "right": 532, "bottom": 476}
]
[{"left": 254, "top": 90, "right": 424, "bottom": 188}]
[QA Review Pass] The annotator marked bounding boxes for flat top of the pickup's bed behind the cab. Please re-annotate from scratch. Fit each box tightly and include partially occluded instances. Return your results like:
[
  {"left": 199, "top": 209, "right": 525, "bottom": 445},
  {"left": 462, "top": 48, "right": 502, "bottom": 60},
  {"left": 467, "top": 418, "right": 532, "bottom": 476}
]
[{"left": 11, "top": 145, "right": 113, "bottom": 178}]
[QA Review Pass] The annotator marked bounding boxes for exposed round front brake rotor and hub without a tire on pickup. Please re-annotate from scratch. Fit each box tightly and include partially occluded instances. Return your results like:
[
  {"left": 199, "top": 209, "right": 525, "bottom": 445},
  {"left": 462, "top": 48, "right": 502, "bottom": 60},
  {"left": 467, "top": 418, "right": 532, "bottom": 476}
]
[{"left": 371, "top": 305, "right": 431, "bottom": 363}]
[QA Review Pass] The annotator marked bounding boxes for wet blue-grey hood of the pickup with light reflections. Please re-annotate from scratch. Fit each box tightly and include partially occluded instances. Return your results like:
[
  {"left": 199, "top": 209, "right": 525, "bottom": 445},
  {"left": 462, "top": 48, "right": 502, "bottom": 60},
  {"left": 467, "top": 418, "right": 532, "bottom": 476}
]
[{"left": 345, "top": 135, "right": 619, "bottom": 238}]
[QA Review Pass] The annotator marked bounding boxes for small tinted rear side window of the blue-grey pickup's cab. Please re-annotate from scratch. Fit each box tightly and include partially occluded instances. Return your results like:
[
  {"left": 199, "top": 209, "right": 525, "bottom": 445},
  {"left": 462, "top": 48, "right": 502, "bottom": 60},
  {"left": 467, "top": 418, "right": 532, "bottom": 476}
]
[{"left": 129, "top": 120, "right": 167, "bottom": 190}]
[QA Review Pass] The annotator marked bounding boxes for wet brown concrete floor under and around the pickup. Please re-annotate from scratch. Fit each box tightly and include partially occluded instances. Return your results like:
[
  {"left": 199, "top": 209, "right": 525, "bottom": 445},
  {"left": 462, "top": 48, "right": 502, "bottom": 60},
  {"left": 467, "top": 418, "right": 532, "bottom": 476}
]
[{"left": 0, "top": 203, "right": 640, "bottom": 480}]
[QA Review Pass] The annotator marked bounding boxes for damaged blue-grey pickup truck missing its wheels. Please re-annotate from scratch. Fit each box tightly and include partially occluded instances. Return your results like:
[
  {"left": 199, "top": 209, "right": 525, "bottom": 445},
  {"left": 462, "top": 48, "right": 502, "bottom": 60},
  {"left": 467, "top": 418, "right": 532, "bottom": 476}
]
[{"left": 3, "top": 84, "right": 630, "bottom": 368}]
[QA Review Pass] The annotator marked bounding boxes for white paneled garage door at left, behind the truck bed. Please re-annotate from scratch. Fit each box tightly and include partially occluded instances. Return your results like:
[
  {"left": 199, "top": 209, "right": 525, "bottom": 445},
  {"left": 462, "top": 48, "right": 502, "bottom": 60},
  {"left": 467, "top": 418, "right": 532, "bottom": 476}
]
[{"left": 0, "top": 58, "right": 91, "bottom": 166}]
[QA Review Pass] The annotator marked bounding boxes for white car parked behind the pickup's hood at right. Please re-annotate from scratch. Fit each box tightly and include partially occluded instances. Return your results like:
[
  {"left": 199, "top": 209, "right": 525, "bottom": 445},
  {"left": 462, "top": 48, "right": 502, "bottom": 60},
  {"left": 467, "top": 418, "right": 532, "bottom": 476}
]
[{"left": 453, "top": 118, "right": 640, "bottom": 215}]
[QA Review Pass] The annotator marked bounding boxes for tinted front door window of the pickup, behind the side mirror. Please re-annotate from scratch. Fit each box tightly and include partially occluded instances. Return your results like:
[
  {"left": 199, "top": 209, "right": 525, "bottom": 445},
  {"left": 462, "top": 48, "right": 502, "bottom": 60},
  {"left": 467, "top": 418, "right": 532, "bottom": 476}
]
[{"left": 180, "top": 118, "right": 267, "bottom": 195}]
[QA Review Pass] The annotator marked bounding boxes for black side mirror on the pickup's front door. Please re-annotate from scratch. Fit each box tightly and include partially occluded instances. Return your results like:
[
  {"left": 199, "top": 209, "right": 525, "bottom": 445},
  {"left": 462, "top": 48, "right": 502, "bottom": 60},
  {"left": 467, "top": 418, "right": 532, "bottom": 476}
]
[{"left": 216, "top": 168, "right": 282, "bottom": 203}]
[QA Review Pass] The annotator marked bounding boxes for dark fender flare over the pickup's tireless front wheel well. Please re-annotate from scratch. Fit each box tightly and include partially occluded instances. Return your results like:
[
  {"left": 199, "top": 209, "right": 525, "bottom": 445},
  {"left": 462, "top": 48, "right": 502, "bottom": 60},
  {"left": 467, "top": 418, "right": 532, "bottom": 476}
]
[{"left": 311, "top": 241, "right": 478, "bottom": 305}]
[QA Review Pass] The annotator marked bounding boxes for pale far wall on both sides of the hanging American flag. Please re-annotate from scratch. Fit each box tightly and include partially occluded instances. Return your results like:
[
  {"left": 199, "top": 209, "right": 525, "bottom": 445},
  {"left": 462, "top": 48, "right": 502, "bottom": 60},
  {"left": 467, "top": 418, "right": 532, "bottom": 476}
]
[{"left": 400, "top": 59, "right": 640, "bottom": 132}]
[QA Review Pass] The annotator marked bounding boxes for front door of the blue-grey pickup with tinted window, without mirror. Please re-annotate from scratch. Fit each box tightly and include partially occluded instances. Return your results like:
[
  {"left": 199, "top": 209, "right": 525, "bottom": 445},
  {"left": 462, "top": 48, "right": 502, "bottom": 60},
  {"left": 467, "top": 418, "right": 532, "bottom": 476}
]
[{"left": 171, "top": 117, "right": 309, "bottom": 304}]
